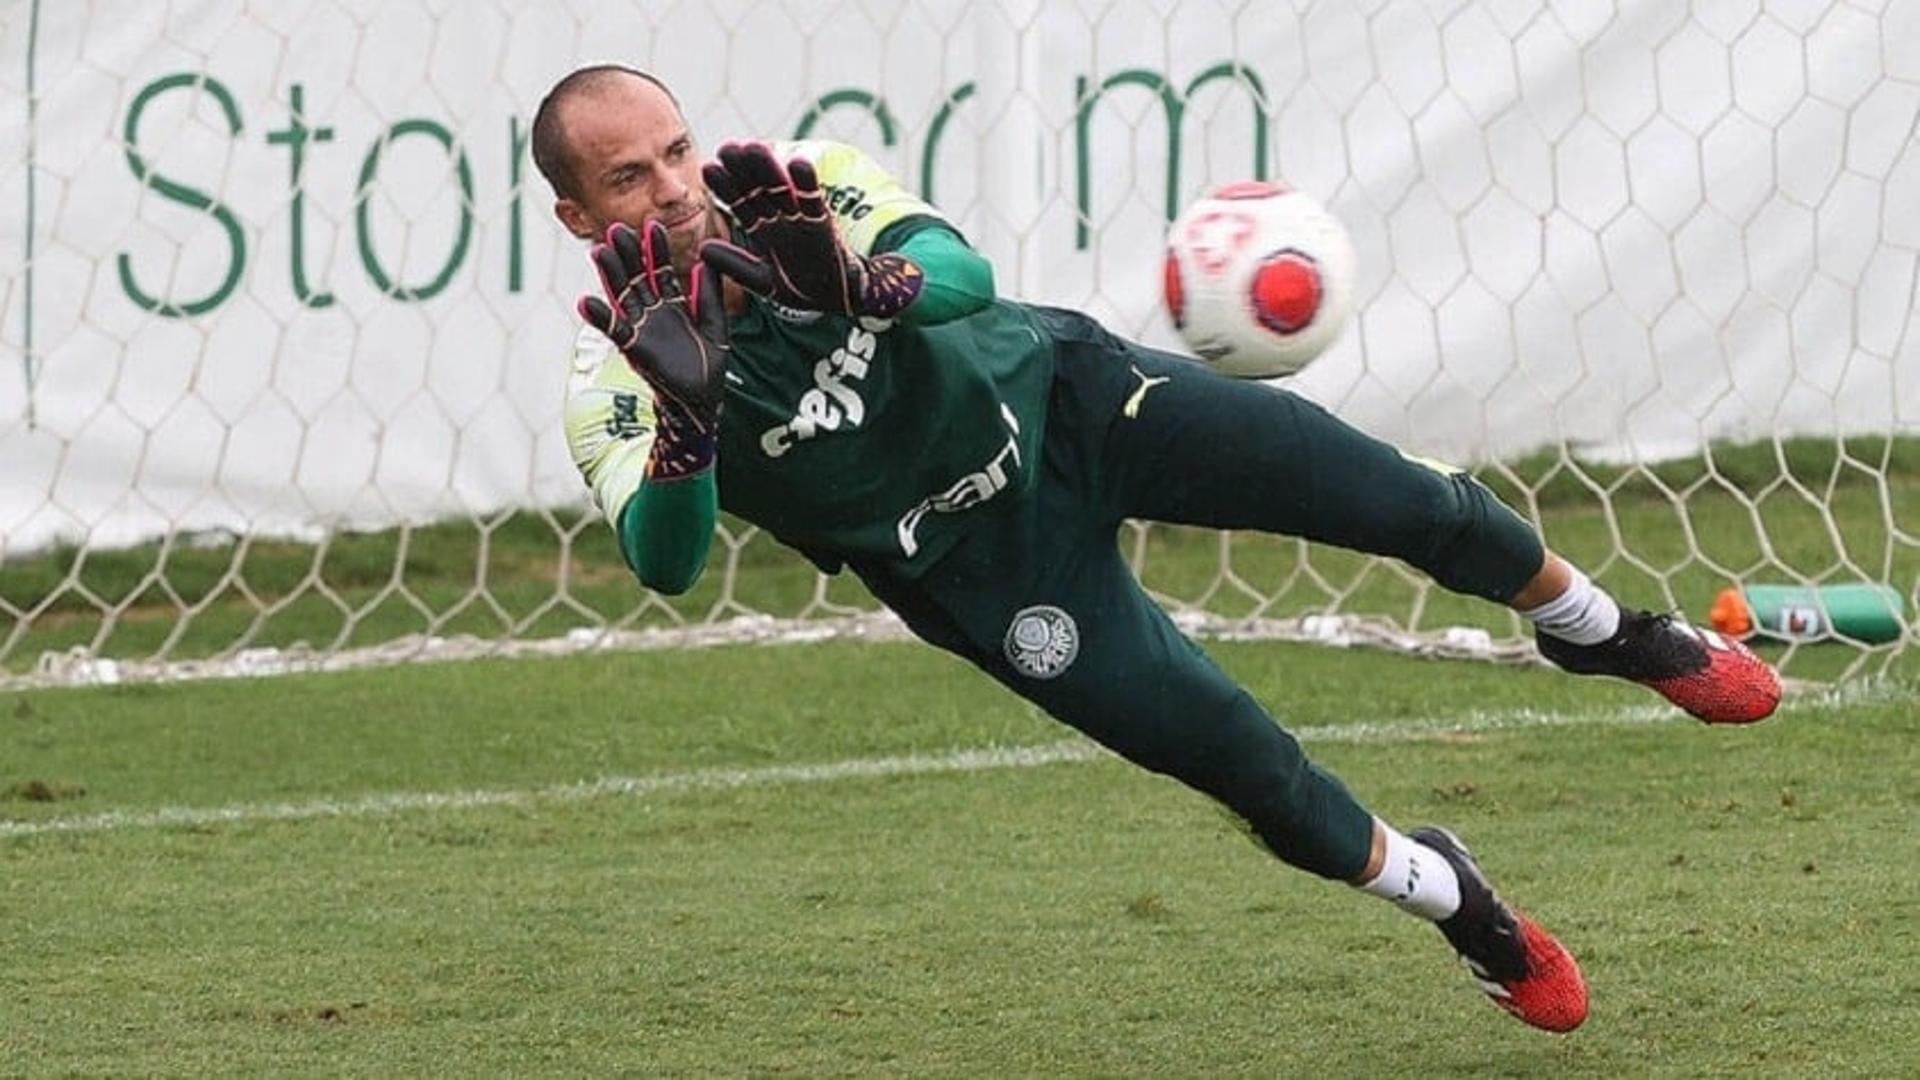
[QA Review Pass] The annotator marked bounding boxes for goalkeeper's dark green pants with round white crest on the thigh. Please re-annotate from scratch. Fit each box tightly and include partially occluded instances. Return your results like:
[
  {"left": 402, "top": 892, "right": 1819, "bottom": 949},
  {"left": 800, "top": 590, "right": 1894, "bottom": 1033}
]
[{"left": 854, "top": 311, "right": 1544, "bottom": 880}]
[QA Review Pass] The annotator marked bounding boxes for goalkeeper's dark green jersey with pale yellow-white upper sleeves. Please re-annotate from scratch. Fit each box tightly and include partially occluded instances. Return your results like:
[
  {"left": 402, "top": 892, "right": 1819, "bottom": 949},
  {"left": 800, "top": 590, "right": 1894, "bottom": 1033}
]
[{"left": 566, "top": 142, "right": 1052, "bottom": 573}]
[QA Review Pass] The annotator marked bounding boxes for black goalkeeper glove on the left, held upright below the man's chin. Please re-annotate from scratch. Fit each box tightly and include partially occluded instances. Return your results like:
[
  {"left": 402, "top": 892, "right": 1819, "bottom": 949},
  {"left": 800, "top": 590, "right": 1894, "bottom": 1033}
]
[{"left": 580, "top": 219, "right": 732, "bottom": 480}]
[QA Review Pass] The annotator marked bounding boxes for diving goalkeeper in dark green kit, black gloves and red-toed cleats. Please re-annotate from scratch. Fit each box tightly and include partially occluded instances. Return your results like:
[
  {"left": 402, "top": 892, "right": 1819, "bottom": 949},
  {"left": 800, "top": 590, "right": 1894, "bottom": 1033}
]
[{"left": 532, "top": 65, "right": 1780, "bottom": 1030}]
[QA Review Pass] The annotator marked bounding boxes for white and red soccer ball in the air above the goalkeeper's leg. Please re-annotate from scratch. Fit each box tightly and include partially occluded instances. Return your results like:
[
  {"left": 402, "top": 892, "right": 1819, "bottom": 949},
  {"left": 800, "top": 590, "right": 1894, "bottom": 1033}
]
[{"left": 1164, "top": 181, "right": 1354, "bottom": 379}]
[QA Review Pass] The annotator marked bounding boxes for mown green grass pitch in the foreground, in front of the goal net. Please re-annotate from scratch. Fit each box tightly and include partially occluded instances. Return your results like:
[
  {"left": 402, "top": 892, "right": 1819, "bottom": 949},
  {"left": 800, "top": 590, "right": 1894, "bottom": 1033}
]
[{"left": 0, "top": 644, "right": 1920, "bottom": 1076}]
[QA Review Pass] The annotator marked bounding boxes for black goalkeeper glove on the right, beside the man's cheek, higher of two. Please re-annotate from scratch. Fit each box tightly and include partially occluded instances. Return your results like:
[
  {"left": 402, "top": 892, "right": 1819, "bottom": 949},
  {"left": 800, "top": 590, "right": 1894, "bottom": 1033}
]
[{"left": 701, "top": 142, "right": 925, "bottom": 319}]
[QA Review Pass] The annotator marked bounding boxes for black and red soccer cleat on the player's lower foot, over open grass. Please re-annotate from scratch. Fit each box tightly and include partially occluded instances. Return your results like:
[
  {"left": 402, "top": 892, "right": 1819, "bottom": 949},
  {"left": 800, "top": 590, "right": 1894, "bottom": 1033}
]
[{"left": 1407, "top": 824, "right": 1586, "bottom": 1032}]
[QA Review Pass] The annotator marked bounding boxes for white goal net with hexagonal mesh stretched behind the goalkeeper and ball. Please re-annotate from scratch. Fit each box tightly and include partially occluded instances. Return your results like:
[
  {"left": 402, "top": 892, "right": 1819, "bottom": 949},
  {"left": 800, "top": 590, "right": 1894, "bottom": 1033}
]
[{"left": 0, "top": 0, "right": 1920, "bottom": 682}]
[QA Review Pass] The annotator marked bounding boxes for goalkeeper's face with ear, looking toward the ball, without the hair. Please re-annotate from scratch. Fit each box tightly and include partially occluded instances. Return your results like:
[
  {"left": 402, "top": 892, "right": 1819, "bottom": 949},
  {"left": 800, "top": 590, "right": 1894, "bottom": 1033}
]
[{"left": 555, "top": 77, "right": 726, "bottom": 275}]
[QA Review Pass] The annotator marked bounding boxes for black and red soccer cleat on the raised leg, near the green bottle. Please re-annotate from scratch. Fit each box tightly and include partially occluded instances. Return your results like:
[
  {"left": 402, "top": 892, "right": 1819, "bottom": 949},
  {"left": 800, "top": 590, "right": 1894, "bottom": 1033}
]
[{"left": 1534, "top": 611, "right": 1780, "bottom": 724}]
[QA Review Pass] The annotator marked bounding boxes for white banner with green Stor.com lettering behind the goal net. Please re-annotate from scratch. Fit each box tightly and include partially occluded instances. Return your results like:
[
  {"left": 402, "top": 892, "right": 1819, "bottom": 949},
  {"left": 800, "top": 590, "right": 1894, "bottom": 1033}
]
[{"left": 0, "top": 0, "right": 1920, "bottom": 555}]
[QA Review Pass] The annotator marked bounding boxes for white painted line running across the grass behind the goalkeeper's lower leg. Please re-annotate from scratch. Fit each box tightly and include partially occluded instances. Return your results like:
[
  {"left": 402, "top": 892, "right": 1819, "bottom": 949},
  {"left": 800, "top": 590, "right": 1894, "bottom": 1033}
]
[{"left": 0, "top": 684, "right": 1899, "bottom": 840}]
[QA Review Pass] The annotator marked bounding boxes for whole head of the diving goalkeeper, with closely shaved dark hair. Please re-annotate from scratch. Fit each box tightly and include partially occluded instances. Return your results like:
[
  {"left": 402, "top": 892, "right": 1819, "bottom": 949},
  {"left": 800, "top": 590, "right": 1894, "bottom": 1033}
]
[{"left": 532, "top": 63, "right": 726, "bottom": 275}]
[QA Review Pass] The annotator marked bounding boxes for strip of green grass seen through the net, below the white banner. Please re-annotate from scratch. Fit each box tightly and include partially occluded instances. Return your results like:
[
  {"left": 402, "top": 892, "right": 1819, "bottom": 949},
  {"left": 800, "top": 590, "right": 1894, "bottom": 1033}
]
[{"left": 0, "top": 438, "right": 1920, "bottom": 678}]
